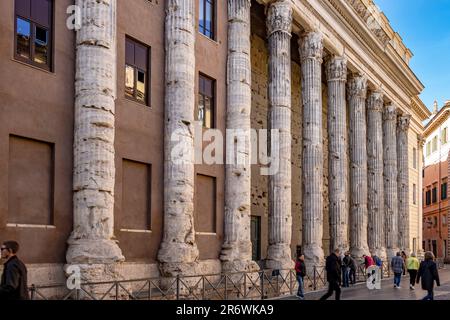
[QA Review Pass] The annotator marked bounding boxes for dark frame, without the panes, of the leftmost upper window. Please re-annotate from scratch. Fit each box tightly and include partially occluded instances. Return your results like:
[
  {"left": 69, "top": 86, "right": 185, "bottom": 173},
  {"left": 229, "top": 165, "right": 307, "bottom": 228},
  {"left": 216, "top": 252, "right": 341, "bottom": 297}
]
[{"left": 14, "top": 0, "right": 55, "bottom": 72}]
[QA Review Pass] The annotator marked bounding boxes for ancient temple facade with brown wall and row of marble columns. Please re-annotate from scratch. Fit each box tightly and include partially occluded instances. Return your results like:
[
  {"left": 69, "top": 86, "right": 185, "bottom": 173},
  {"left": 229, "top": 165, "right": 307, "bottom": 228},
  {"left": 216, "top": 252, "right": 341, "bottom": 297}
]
[{"left": 0, "top": 0, "right": 430, "bottom": 284}]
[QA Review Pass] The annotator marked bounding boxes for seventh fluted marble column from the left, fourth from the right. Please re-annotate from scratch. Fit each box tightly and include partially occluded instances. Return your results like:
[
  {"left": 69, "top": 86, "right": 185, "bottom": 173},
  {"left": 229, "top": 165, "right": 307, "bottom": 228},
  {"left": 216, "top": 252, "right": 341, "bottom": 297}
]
[{"left": 347, "top": 75, "right": 369, "bottom": 257}]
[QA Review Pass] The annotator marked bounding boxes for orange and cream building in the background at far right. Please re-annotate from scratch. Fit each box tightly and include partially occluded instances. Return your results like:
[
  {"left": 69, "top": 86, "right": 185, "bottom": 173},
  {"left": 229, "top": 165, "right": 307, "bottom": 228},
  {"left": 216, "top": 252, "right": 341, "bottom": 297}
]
[{"left": 422, "top": 101, "right": 450, "bottom": 261}]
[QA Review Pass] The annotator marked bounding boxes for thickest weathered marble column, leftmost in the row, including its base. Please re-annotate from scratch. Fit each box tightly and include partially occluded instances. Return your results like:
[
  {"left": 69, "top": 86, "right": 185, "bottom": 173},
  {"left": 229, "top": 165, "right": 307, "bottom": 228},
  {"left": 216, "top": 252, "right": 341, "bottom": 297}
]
[{"left": 66, "top": 0, "right": 124, "bottom": 281}]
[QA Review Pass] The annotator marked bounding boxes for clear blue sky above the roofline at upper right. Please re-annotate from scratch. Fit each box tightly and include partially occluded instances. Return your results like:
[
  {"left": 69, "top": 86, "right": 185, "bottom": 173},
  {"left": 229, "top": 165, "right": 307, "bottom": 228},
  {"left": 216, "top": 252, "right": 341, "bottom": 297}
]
[{"left": 375, "top": 0, "right": 450, "bottom": 109}]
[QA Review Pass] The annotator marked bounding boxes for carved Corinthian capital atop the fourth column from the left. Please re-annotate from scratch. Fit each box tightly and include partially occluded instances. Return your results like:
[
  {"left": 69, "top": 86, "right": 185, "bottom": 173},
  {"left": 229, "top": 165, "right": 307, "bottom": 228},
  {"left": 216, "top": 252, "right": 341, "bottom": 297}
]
[{"left": 267, "top": 0, "right": 292, "bottom": 37}]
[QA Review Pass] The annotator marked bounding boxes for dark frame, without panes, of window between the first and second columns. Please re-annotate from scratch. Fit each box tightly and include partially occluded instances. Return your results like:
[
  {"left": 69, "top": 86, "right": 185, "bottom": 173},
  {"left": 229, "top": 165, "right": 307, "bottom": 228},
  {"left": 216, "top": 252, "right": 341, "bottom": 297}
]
[{"left": 123, "top": 35, "right": 152, "bottom": 107}]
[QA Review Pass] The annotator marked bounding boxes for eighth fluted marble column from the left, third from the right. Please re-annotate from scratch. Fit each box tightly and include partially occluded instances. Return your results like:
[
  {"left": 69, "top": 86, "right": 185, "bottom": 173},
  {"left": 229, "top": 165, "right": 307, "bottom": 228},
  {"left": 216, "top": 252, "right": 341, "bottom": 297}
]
[{"left": 367, "top": 91, "right": 386, "bottom": 260}]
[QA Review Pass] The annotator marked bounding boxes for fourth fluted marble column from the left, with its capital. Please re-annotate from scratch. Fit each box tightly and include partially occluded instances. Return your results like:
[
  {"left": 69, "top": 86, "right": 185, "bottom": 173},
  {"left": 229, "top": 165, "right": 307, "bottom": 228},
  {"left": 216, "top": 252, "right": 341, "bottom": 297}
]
[{"left": 266, "top": 1, "right": 293, "bottom": 269}]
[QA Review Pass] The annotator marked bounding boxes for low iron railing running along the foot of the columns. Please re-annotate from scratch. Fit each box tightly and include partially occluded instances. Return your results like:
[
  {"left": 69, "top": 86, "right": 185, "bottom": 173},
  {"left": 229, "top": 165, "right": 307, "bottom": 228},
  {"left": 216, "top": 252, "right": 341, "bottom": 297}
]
[{"left": 29, "top": 263, "right": 391, "bottom": 300}]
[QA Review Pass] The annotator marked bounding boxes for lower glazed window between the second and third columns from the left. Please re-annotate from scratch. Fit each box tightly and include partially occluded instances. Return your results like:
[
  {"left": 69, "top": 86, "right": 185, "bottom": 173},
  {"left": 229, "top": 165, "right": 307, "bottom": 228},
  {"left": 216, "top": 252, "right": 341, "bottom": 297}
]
[{"left": 197, "top": 75, "right": 216, "bottom": 128}]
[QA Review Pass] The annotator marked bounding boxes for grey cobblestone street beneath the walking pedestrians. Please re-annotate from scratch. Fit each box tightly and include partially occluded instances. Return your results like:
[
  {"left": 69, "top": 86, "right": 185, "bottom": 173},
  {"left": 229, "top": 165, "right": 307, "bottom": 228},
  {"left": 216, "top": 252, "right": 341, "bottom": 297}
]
[{"left": 281, "top": 265, "right": 450, "bottom": 300}]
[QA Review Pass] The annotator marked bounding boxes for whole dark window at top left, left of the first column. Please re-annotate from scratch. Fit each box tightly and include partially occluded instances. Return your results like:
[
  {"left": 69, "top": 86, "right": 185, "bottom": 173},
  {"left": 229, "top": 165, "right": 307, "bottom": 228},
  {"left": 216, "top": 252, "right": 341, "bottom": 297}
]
[{"left": 14, "top": 0, "right": 53, "bottom": 70}]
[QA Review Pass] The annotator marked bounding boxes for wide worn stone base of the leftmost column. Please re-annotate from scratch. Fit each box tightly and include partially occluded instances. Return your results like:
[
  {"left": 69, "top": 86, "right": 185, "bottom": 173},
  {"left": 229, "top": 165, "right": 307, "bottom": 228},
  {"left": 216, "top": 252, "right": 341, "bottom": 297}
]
[{"left": 66, "top": 237, "right": 125, "bottom": 265}]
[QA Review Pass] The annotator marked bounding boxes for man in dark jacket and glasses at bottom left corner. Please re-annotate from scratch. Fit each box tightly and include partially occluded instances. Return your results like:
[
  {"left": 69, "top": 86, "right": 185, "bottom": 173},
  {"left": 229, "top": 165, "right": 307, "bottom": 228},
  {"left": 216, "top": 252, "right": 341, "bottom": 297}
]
[{"left": 0, "top": 241, "right": 29, "bottom": 300}]
